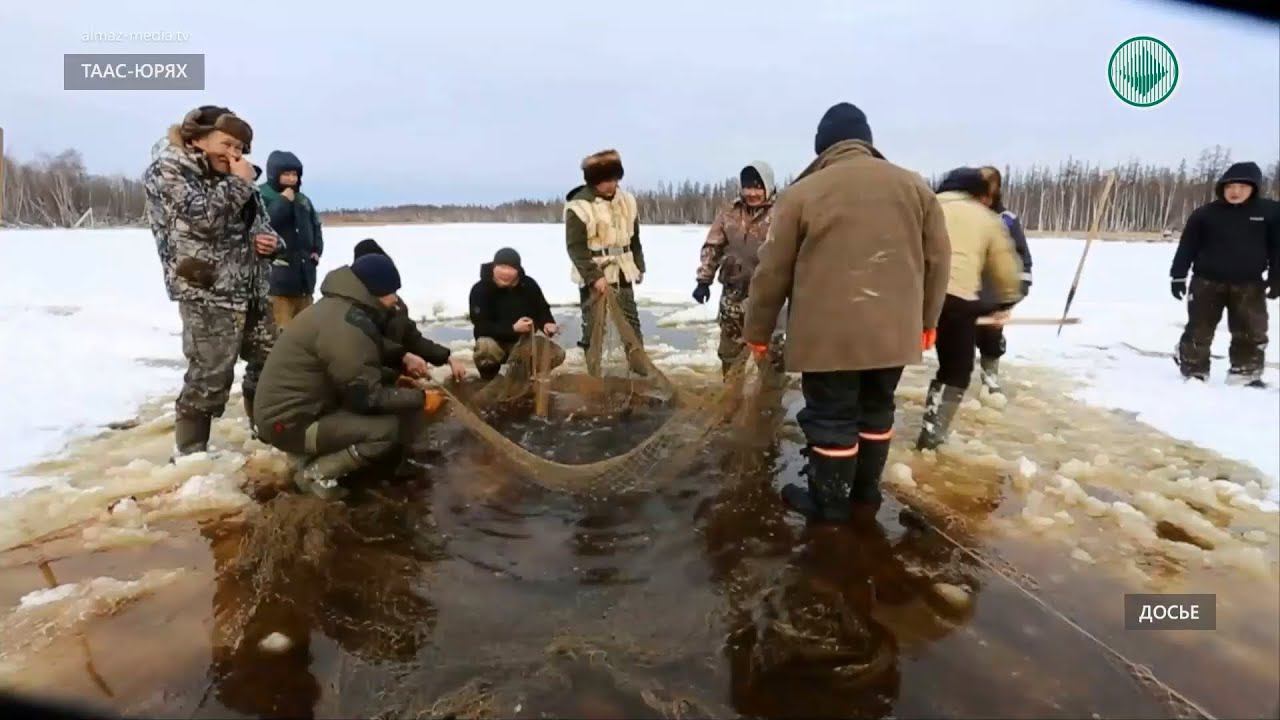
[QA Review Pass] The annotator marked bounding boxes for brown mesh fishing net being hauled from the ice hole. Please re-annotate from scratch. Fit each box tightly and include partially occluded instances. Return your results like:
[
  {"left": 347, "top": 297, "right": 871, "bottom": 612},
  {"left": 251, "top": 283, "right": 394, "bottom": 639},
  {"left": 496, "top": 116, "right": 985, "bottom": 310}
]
[{"left": 432, "top": 285, "right": 777, "bottom": 495}]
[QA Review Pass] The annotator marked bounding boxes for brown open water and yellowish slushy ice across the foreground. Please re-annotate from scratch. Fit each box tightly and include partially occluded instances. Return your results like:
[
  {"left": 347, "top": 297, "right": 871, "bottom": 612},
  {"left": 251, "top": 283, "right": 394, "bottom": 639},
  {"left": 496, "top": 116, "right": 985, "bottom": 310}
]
[{"left": 0, "top": 317, "right": 1280, "bottom": 717}]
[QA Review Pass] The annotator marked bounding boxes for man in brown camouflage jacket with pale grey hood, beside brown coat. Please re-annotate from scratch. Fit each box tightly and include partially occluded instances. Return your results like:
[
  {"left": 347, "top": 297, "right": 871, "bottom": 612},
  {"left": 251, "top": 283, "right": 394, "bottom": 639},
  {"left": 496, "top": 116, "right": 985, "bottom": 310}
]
[{"left": 694, "top": 161, "right": 782, "bottom": 373}]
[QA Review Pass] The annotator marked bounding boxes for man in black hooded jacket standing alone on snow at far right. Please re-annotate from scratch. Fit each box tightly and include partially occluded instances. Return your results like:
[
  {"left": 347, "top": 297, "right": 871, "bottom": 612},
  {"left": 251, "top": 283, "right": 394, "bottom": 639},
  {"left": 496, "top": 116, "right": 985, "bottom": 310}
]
[{"left": 1169, "top": 163, "right": 1280, "bottom": 387}]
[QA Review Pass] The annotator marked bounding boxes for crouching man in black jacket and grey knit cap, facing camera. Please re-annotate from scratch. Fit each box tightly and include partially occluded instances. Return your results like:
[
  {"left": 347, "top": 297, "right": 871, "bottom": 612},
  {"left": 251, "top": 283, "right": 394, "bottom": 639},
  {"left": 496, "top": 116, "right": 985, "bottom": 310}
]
[{"left": 471, "top": 247, "right": 564, "bottom": 380}]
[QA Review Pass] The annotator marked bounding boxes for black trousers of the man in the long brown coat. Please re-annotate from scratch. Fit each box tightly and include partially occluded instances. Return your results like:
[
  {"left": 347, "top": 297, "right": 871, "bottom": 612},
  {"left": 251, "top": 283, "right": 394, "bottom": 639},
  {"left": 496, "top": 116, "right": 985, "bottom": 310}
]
[{"left": 796, "top": 366, "right": 906, "bottom": 450}]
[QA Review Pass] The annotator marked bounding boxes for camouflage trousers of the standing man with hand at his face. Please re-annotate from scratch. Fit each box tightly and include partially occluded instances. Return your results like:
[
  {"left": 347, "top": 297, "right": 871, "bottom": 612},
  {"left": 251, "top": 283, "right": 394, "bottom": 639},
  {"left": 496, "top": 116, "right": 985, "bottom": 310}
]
[{"left": 175, "top": 301, "right": 275, "bottom": 418}]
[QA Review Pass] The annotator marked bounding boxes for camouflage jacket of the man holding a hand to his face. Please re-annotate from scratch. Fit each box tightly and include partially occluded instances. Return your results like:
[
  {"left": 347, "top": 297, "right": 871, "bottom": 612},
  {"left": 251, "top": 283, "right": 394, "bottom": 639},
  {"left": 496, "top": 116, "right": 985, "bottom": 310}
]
[{"left": 142, "top": 137, "right": 283, "bottom": 311}]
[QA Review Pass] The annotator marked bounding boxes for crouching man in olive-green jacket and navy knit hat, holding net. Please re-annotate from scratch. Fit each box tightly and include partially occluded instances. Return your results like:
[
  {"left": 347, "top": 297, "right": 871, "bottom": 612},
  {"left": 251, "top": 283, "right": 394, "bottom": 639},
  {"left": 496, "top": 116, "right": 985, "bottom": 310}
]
[{"left": 255, "top": 254, "right": 436, "bottom": 496}]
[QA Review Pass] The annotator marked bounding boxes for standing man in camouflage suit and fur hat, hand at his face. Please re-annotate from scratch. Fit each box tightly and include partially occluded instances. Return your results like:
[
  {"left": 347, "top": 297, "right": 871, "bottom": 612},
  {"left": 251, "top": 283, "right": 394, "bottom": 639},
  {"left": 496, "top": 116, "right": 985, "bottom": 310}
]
[{"left": 143, "top": 105, "right": 283, "bottom": 455}]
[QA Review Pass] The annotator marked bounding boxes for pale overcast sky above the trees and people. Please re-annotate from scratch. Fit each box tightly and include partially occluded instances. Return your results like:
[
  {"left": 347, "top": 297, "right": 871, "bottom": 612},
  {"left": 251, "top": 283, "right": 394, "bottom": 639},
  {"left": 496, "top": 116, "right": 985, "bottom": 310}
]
[{"left": 0, "top": 0, "right": 1280, "bottom": 208}]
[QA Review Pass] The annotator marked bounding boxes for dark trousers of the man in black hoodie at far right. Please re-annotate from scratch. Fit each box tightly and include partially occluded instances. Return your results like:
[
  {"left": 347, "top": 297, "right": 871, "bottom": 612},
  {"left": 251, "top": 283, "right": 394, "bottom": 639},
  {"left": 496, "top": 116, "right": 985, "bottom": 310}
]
[{"left": 1178, "top": 277, "right": 1267, "bottom": 375}]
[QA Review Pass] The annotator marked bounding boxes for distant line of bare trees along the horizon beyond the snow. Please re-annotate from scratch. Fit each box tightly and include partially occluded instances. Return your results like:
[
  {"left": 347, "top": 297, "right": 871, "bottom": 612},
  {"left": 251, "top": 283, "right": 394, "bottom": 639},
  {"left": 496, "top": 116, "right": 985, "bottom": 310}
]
[{"left": 3, "top": 146, "right": 1280, "bottom": 233}]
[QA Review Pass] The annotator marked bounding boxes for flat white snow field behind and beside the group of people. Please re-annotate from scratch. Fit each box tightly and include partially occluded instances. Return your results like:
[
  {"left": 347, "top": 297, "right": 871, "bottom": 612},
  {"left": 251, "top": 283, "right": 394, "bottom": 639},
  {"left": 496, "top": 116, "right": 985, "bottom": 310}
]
[{"left": 0, "top": 224, "right": 1280, "bottom": 498}]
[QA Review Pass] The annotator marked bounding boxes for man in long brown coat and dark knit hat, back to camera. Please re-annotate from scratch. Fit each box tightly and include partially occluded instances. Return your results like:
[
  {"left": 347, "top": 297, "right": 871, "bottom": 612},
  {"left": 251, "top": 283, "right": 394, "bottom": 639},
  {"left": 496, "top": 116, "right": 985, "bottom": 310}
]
[{"left": 742, "top": 102, "right": 951, "bottom": 521}]
